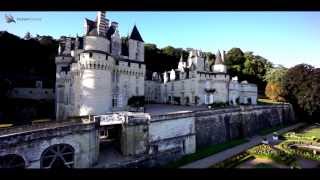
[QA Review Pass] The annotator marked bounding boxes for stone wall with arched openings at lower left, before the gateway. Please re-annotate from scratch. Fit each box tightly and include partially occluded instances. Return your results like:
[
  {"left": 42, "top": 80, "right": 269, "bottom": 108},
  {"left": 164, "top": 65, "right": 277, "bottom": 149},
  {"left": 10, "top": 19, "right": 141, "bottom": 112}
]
[{"left": 0, "top": 119, "right": 99, "bottom": 168}]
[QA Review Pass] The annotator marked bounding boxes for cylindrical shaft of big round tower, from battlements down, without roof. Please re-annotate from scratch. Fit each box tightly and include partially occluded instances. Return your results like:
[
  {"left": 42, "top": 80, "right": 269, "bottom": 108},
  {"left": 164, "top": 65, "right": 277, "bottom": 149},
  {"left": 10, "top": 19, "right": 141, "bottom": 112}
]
[{"left": 78, "top": 50, "right": 114, "bottom": 116}]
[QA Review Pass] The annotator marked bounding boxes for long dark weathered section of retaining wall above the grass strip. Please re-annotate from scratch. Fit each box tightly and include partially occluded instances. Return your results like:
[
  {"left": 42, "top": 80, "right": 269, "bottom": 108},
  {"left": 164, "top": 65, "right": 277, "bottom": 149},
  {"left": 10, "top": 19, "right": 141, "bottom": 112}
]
[{"left": 195, "top": 104, "right": 295, "bottom": 148}]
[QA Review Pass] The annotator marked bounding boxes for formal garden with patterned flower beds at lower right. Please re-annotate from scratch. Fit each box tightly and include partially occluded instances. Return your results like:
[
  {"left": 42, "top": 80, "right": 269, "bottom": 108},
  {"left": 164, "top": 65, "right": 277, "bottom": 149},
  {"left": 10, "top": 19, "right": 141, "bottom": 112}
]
[{"left": 211, "top": 124, "right": 320, "bottom": 169}]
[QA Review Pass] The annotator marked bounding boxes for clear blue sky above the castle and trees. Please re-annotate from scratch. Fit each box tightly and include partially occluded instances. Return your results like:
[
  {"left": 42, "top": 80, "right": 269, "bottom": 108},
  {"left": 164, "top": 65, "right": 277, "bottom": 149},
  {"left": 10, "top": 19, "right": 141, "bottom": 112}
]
[{"left": 0, "top": 11, "right": 320, "bottom": 67}]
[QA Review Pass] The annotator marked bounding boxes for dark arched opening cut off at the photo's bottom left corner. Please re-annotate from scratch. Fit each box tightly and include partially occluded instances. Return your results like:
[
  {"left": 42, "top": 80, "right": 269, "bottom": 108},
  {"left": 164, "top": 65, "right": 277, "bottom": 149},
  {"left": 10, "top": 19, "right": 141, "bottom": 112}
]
[{"left": 0, "top": 154, "right": 25, "bottom": 168}]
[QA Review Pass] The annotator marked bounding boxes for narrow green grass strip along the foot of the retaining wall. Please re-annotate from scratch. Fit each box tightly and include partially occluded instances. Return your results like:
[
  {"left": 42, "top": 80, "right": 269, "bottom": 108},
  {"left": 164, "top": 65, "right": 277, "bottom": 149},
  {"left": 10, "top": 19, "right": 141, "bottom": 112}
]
[{"left": 165, "top": 139, "right": 248, "bottom": 168}]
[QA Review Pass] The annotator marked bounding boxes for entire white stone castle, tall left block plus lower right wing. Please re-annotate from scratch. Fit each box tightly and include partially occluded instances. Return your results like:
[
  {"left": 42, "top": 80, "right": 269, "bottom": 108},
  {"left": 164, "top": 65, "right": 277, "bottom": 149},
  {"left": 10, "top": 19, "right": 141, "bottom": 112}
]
[{"left": 55, "top": 12, "right": 257, "bottom": 119}]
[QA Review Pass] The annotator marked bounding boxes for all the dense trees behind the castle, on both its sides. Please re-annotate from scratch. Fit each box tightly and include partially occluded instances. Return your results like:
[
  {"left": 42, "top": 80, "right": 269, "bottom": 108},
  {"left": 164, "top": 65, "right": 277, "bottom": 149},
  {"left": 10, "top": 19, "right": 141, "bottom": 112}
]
[{"left": 0, "top": 31, "right": 320, "bottom": 124}]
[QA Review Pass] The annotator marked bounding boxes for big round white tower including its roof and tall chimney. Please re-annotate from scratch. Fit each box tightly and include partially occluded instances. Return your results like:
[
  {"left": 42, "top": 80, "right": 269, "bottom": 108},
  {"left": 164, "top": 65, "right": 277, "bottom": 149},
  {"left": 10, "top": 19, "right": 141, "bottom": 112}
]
[{"left": 74, "top": 12, "right": 114, "bottom": 116}]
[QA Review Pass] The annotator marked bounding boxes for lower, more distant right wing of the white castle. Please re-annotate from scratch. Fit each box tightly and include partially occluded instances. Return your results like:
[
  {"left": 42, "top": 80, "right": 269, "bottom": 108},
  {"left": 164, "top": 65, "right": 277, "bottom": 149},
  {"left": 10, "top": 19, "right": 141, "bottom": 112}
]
[{"left": 145, "top": 49, "right": 257, "bottom": 105}]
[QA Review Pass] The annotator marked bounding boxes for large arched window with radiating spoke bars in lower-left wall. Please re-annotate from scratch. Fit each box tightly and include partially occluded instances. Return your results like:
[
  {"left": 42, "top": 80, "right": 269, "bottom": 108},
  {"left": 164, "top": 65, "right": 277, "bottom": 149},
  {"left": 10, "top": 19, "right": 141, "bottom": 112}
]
[{"left": 40, "top": 144, "right": 74, "bottom": 168}]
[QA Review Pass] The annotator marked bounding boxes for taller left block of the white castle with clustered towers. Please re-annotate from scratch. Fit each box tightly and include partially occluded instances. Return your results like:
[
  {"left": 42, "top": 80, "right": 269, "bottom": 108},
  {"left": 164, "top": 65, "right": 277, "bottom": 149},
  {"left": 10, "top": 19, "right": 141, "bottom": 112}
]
[{"left": 56, "top": 12, "right": 146, "bottom": 119}]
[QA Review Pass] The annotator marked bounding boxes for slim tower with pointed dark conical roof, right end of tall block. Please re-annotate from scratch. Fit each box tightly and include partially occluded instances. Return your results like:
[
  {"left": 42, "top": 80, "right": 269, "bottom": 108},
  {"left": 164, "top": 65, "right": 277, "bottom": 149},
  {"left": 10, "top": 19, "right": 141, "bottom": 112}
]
[{"left": 129, "top": 25, "right": 144, "bottom": 62}]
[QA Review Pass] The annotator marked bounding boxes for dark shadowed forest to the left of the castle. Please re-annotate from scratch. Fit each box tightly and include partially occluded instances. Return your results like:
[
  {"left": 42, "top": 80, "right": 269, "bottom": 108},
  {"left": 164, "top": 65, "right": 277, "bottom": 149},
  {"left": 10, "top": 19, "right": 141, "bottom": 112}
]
[{"left": 0, "top": 31, "right": 58, "bottom": 124}]
